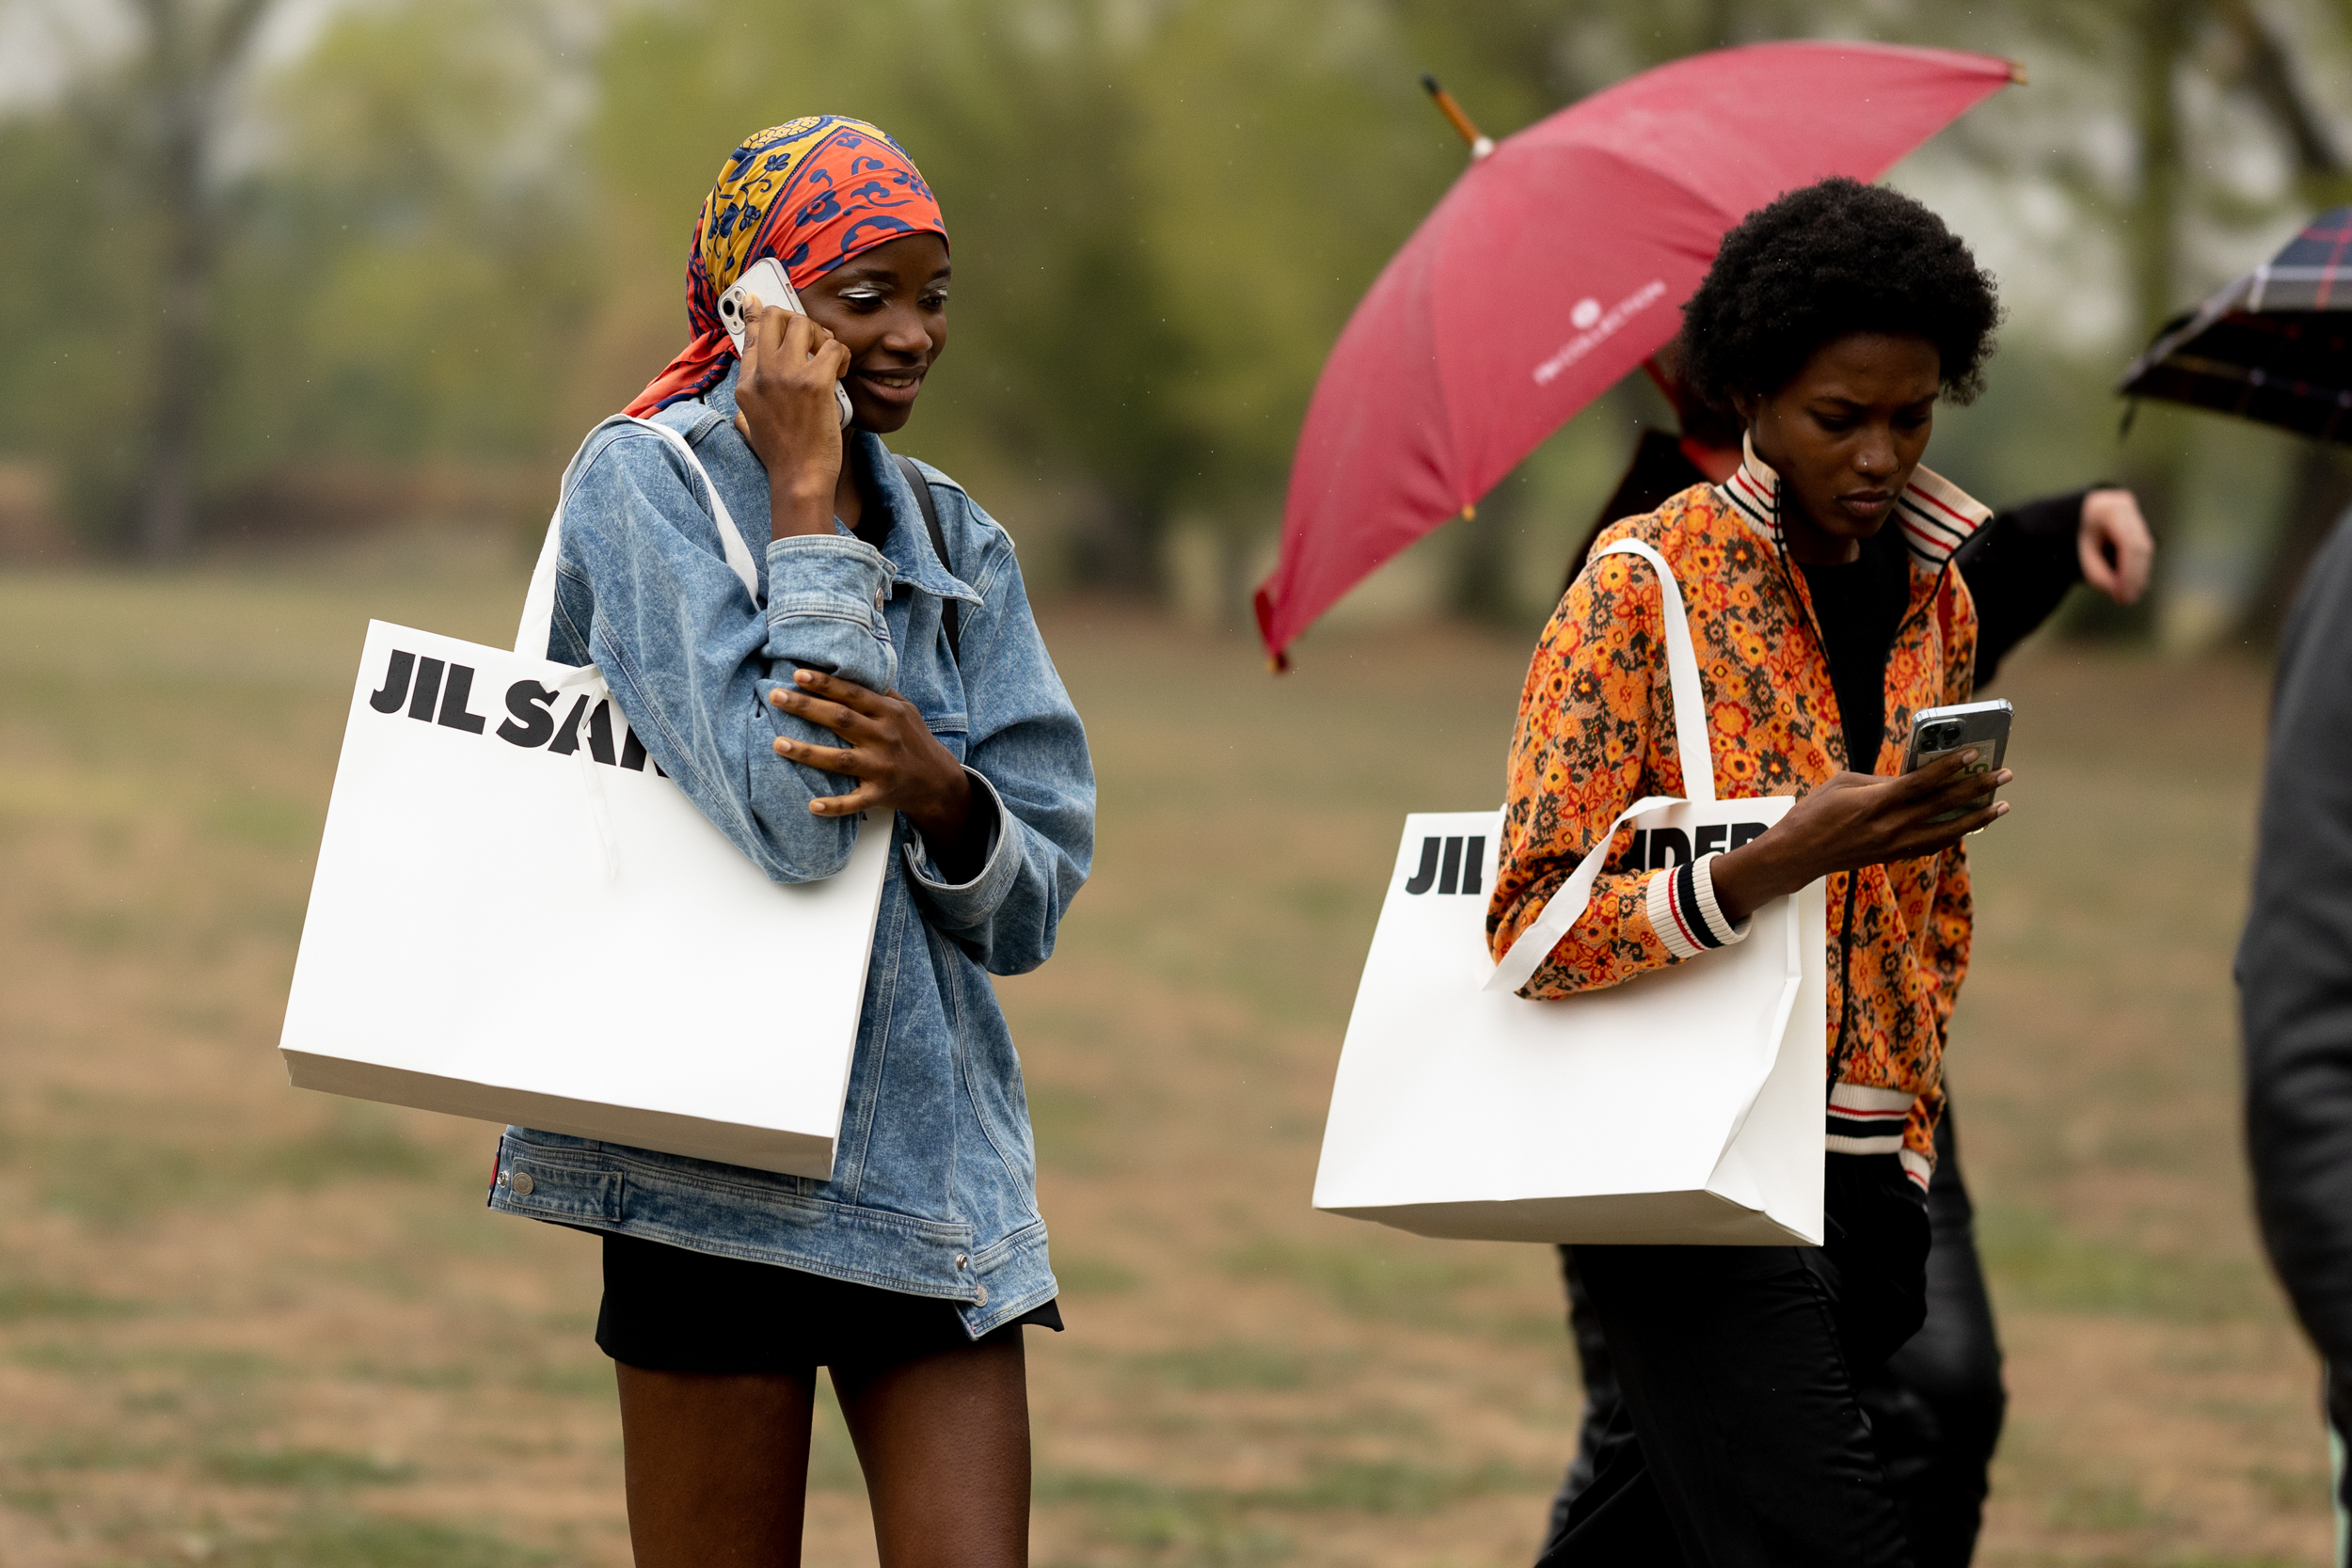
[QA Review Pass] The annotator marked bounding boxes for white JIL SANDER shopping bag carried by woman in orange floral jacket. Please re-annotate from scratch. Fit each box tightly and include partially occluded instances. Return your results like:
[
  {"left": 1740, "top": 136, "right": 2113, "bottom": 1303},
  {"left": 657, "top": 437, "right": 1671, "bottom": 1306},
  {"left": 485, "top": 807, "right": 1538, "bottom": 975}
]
[{"left": 1315, "top": 541, "right": 1828, "bottom": 1246}]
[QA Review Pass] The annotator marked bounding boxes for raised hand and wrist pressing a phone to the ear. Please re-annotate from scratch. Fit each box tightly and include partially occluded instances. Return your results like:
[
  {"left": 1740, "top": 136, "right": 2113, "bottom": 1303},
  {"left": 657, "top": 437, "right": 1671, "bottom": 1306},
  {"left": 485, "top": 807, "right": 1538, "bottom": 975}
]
[{"left": 737, "top": 296, "right": 850, "bottom": 538}]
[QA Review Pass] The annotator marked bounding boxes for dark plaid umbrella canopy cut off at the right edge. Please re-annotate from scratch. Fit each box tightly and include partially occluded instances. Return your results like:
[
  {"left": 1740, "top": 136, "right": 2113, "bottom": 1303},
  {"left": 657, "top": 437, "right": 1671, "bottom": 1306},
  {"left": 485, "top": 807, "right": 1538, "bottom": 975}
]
[{"left": 2115, "top": 207, "right": 2352, "bottom": 444}]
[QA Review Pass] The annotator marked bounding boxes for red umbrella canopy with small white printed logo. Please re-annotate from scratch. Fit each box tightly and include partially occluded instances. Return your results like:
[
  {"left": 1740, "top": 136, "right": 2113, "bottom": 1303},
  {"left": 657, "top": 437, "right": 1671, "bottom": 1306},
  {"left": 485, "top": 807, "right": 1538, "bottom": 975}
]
[{"left": 1259, "top": 42, "right": 2023, "bottom": 663}]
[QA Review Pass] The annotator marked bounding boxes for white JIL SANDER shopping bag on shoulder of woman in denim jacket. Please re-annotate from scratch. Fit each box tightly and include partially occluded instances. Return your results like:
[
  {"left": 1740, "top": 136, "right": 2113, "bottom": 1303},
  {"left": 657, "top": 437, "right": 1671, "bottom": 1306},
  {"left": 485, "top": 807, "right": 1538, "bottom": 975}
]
[{"left": 280, "top": 425, "right": 892, "bottom": 1180}]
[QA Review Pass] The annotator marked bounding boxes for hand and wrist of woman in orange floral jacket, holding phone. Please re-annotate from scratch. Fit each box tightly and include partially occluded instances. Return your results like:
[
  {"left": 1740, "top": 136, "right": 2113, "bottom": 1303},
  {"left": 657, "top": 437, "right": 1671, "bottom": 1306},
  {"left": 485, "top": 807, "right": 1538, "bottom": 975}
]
[{"left": 1708, "top": 748, "right": 2016, "bottom": 927}]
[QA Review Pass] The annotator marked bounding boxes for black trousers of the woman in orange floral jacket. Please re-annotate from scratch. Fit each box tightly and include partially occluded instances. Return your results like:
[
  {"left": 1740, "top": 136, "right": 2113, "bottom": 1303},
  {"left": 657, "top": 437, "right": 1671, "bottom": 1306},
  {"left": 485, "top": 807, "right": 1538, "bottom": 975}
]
[{"left": 1541, "top": 1154, "right": 1929, "bottom": 1568}]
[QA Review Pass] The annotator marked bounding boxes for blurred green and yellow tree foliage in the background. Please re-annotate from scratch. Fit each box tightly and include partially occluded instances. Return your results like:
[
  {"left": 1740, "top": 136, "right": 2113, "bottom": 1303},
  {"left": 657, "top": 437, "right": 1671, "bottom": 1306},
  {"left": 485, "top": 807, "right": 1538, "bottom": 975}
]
[{"left": 0, "top": 0, "right": 2352, "bottom": 618}]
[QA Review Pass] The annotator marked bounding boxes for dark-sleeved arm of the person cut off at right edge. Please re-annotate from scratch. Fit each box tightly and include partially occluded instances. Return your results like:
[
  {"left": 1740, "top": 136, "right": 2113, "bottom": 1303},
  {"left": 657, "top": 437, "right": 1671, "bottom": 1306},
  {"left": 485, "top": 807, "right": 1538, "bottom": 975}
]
[{"left": 2237, "top": 527, "right": 2352, "bottom": 1369}]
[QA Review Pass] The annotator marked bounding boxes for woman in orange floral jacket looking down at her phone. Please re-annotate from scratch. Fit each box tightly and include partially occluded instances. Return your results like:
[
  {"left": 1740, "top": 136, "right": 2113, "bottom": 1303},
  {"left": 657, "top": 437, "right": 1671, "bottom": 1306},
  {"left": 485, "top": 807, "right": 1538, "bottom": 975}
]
[{"left": 1486, "top": 179, "right": 2009, "bottom": 1568}]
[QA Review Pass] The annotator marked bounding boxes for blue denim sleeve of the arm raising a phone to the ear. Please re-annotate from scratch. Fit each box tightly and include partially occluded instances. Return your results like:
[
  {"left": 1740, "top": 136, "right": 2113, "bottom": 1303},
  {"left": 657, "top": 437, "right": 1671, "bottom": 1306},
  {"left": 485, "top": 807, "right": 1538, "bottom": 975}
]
[{"left": 558, "top": 433, "right": 898, "bottom": 881}]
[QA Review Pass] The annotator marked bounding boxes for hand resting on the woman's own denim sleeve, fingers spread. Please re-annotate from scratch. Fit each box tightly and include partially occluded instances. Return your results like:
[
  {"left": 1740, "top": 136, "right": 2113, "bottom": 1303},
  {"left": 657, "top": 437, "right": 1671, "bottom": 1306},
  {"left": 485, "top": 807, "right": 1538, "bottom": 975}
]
[{"left": 767, "top": 670, "right": 972, "bottom": 846}]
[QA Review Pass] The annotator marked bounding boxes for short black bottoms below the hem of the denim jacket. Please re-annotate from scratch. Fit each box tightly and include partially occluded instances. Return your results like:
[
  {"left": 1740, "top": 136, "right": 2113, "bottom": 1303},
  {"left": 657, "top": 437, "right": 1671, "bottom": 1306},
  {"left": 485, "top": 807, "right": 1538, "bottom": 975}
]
[{"left": 596, "top": 1232, "right": 1061, "bottom": 1373}]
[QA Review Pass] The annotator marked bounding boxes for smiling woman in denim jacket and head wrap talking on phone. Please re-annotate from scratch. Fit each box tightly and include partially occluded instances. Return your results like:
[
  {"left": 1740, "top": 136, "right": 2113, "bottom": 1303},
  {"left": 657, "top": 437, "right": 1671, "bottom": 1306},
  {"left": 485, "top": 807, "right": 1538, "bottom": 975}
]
[{"left": 492, "top": 115, "right": 1094, "bottom": 1568}]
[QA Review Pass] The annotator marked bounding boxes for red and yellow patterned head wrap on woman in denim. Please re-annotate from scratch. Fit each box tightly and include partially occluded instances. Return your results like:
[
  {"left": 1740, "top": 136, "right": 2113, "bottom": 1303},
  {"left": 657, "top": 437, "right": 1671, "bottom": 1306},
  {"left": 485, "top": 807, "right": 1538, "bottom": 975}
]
[{"left": 628, "top": 115, "right": 948, "bottom": 419}]
